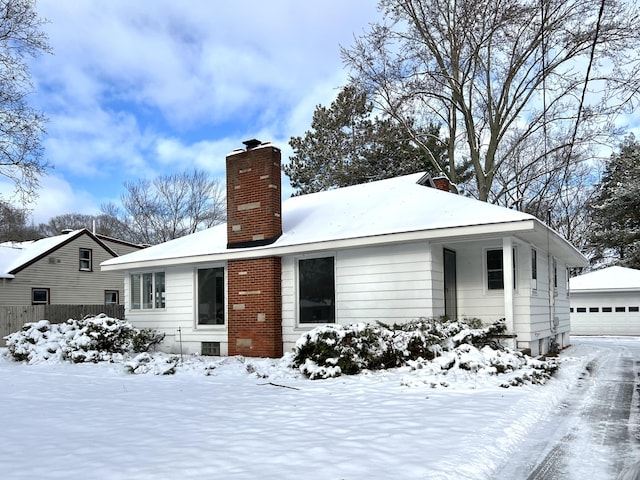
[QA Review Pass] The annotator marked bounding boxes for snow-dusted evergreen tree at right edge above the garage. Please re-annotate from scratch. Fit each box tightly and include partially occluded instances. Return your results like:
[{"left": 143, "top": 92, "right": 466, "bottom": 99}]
[{"left": 588, "top": 135, "right": 640, "bottom": 268}]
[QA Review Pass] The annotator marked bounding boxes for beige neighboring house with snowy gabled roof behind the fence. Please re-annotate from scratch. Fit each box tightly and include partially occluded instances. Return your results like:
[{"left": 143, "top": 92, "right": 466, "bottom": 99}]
[{"left": 0, "top": 229, "right": 142, "bottom": 306}]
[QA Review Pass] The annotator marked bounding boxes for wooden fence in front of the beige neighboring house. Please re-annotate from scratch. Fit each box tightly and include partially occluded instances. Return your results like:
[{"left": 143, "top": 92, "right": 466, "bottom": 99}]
[{"left": 0, "top": 305, "right": 124, "bottom": 346}]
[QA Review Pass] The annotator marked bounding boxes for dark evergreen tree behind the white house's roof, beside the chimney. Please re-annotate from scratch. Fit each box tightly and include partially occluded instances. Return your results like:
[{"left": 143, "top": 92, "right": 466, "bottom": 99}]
[{"left": 284, "top": 86, "right": 456, "bottom": 194}]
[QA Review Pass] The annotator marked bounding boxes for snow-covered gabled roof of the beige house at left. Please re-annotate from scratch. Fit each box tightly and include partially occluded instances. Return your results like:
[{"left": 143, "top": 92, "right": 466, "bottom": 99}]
[{"left": 0, "top": 228, "right": 116, "bottom": 278}]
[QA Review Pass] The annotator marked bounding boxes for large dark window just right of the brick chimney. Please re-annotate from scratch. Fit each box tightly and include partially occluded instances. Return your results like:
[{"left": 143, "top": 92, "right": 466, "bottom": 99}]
[{"left": 298, "top": 257, "right": 335, "bottom": 323}]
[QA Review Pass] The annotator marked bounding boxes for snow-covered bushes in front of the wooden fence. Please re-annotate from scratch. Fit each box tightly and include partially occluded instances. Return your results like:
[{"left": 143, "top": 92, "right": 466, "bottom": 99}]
[{"left": 4, "top": 314, "right": 164, "bottom": 363}]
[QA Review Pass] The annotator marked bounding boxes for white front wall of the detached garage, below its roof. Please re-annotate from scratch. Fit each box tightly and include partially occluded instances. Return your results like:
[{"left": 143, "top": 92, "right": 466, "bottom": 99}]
[{"left": 570, "top": 291, "right": 640, "bottom": 335}]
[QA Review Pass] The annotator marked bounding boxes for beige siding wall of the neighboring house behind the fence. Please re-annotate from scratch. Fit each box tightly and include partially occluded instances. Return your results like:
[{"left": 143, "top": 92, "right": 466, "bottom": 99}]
[{"left": 0, "top": 235, "right": 123, "bottom": 305}]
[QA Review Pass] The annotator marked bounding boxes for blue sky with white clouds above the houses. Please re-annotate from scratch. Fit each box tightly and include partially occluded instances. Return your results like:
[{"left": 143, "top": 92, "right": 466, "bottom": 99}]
[{"left": 6, "top": 0, "right": 380, "bottom": 224}]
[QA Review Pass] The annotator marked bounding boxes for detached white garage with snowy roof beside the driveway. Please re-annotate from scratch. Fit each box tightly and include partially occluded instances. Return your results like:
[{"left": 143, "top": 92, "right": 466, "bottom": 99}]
[{"left": 569, "top": 267, "right": 640, "bottom": 335}]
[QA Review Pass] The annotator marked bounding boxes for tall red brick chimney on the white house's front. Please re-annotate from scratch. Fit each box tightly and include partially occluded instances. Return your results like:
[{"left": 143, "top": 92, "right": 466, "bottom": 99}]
[{"left": 227, "top": 140, "right": 283, "bottom": 358}]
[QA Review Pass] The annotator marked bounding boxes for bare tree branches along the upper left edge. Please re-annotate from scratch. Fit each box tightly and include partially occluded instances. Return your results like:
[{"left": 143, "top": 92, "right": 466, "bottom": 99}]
[{"left": 0, "top": 0, "right": 51, "bottom": 202}]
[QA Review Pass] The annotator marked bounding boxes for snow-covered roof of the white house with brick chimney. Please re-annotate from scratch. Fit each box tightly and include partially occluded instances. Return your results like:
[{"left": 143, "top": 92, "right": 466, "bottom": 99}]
[{"left": 102, "top": 173, "right": 586, "bottom": 269}]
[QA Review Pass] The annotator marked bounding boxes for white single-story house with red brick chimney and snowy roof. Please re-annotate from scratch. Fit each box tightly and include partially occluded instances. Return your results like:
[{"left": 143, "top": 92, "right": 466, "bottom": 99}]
[{"left": 102, "top": 141, "right": 587, "bottom": 357}]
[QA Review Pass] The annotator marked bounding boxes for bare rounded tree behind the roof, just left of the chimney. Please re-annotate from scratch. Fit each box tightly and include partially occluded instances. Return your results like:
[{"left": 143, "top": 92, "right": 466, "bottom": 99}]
[{"left": 102, "top": 169, "right": 225, "bottom": 245}]
